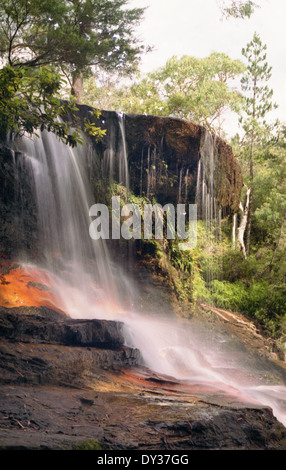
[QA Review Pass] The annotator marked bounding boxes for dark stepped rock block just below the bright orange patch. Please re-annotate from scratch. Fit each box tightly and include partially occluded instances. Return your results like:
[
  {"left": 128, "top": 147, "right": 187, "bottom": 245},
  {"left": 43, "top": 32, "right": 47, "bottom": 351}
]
[{"left": 0, "top": 307, "right": 141, "bottom": 385}]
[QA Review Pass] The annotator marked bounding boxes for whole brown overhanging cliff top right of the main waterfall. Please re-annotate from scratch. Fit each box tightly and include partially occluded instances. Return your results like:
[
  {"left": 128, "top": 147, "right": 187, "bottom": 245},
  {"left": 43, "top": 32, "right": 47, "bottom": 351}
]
[{"left": 71, "top": 106, "right": 243, "bottom": 212}]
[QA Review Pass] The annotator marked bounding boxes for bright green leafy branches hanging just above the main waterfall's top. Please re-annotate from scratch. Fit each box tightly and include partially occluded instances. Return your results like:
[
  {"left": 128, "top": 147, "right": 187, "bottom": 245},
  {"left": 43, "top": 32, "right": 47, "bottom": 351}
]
[{"left": 0, "top": 66, "right": 105, "bottom": 146}]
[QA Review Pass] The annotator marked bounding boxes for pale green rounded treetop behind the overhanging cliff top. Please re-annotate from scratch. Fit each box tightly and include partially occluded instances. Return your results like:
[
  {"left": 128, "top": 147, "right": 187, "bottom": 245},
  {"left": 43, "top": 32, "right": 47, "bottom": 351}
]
[{"left": 101, "top": 53, "right": 245, "bottom": 133}]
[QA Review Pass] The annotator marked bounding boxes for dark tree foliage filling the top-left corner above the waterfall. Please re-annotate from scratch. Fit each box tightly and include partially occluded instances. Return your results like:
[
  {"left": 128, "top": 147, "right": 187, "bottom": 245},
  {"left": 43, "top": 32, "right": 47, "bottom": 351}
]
[{"left": 0, "top": 0, "right": 144, "bottom": 142}]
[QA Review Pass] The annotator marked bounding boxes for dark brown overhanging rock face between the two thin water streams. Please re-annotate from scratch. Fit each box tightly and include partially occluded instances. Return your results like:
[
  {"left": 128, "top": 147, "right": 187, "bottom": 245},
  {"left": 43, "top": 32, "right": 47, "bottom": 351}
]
[{"left": 125, "top": 115, "right": 203, "bottom": 204}]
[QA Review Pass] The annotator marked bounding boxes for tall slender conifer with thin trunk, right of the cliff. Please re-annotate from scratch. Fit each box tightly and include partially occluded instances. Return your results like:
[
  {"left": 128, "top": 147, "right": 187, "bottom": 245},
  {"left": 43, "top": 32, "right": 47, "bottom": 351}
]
[{"left": 240, "top": 33, "right": 276, "bottom": 255}]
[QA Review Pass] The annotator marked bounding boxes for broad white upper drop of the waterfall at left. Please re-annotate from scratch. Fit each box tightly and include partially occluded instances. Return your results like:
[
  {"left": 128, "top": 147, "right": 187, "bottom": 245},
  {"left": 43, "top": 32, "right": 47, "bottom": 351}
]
[{"left": 12, "top": 132, "right": 128, "bottom": 317}]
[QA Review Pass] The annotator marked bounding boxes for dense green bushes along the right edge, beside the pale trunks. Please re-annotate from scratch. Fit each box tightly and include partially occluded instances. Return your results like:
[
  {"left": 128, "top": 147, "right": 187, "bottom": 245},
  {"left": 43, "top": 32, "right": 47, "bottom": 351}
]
[{"left": 214, "top": 127, "right": 286, "bottom": 338}]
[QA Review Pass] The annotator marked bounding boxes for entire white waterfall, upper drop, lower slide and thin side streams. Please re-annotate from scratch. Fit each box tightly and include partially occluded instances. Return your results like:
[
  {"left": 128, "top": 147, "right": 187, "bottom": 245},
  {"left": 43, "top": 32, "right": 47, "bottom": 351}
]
[{"left": 11, "top": 116, "right": 286, "bottom": 430}]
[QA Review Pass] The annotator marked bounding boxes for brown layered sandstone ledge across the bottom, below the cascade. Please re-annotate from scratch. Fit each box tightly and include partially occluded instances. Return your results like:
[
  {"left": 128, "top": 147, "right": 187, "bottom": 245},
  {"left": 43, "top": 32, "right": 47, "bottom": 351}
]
[{"left": 0, "top": 308, "right": 286, "bottom": 450}]
